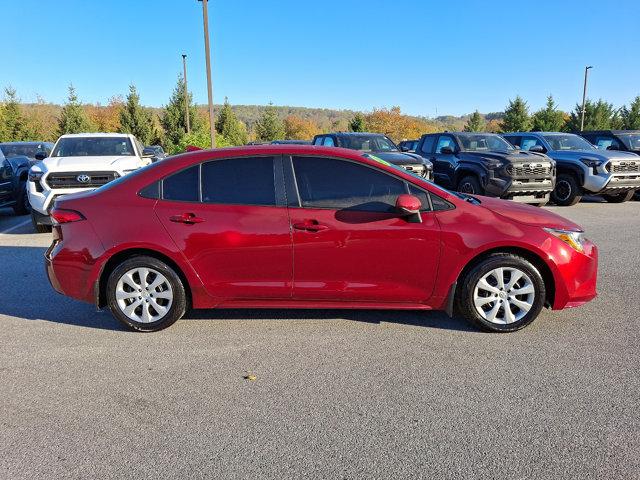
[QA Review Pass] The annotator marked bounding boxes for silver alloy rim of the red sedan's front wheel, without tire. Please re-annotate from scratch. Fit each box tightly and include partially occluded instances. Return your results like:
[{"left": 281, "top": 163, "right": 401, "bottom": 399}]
[{"left": 473, "top": 267, "right": 536, "bottom": 325}]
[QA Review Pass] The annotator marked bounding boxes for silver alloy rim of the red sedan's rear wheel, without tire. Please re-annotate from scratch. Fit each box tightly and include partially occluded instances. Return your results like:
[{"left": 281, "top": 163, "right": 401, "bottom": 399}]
[{"left": 115, "top": 267, "right": 173, "bottom": 323}]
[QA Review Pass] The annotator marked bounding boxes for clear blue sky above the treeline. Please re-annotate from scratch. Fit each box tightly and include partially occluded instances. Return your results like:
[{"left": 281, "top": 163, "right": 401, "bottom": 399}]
[{"left": 0, "top": 0, "right": 640, "bottom": 117}]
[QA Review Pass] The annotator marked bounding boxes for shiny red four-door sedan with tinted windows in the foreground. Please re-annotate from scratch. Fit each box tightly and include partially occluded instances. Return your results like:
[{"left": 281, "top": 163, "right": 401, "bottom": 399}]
[{"left": 46, "top": 145, "right": 597, "bottom": 332}]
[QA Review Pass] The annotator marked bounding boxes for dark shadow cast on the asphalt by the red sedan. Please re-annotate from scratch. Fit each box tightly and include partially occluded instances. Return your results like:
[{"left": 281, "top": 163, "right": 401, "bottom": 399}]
[{"left": 0, "top": 246, "right": 478, "bottom": 332}]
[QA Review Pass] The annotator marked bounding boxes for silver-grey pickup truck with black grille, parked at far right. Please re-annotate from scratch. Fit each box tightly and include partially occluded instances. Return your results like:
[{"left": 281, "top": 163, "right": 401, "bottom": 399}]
[{"left": 503, "top": 132, "right": 640, "bottom": 206}]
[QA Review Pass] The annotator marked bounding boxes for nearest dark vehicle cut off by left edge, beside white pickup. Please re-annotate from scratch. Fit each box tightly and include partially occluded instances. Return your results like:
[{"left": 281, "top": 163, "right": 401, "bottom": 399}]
[{"left": 0, "top": 146, "right": 29, "bottom": 215}]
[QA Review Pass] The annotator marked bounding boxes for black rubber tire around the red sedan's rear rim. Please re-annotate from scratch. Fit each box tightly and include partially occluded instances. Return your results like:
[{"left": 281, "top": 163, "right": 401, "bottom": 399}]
[{"left": 106, "top": 256, "right": 187, "bottom": 332}]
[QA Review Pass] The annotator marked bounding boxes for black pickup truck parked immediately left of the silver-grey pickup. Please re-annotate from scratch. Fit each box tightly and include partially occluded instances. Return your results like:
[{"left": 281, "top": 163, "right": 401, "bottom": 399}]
[{"left": 416, "top": 132, "right": 555, "bottom": 206}]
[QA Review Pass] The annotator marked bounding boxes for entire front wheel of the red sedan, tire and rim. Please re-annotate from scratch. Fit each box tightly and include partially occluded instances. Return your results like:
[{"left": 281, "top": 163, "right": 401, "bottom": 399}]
[{"left": 458, "top": 253, "right": 546, "bottom": 332}]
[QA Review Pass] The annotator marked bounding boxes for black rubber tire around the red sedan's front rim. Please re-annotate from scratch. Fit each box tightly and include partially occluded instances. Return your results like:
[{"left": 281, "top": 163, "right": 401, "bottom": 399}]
[{"left": 456, "top": 253, "right": 546, "bottom": 332}]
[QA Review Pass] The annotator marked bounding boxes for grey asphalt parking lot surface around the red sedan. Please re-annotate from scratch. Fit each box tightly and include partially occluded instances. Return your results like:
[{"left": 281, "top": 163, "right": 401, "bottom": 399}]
[{"left": 0, "top": 202, "right": 640, "bottom": 479}]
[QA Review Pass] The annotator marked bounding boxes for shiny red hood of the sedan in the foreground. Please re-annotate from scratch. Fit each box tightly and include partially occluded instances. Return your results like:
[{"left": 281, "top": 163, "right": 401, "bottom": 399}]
[{"left": 477, "top": 196, "right": 582, "bottom": 231}]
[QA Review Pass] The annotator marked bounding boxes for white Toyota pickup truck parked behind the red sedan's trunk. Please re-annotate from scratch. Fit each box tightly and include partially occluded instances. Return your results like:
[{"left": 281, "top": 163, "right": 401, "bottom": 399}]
[{"left": 27, "top": 133, "right": 151, "bottom": 232}]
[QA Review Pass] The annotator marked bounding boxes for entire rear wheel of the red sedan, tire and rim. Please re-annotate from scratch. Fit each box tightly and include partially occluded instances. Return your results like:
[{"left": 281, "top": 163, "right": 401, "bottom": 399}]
[{"left": 107, "top": 256, "right": 187, "bottom": 332}]
